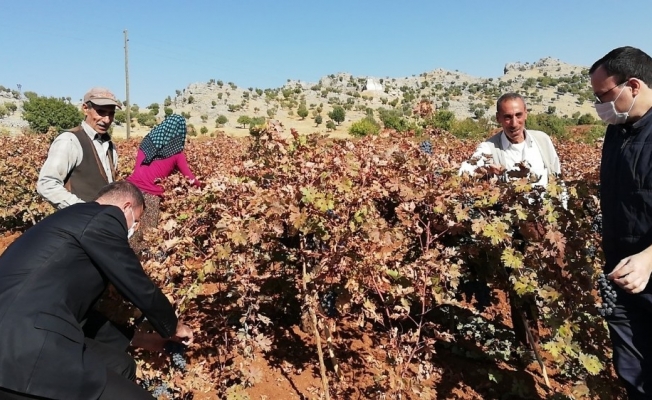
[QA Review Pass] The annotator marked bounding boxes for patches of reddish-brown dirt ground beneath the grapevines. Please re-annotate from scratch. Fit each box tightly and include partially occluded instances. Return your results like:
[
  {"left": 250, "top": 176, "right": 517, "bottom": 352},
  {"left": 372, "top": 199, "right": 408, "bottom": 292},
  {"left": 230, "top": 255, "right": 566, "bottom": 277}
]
[{"left": 0, "top": 232, "right": 618, "bottom": 400}]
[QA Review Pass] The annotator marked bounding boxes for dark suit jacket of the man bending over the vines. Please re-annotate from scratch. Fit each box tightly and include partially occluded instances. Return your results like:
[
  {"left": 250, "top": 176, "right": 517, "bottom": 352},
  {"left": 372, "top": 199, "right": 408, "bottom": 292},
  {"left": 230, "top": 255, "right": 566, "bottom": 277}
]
[{"left": 0, "top": 202, "right": 177, "bottom": 400}]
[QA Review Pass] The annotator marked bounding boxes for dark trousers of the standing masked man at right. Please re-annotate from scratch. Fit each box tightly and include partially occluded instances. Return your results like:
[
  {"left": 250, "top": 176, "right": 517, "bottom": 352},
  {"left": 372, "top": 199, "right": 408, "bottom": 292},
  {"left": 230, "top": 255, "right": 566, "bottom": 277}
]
[{"left": 607, "top": 289, "right": 652, "bottom": 400}]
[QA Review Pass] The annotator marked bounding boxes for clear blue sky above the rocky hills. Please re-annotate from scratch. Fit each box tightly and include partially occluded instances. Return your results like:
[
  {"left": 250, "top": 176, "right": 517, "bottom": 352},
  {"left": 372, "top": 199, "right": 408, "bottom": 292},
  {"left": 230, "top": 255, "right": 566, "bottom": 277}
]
[{"left": 0, "top": 0, "right": 652, "bottom": 106}]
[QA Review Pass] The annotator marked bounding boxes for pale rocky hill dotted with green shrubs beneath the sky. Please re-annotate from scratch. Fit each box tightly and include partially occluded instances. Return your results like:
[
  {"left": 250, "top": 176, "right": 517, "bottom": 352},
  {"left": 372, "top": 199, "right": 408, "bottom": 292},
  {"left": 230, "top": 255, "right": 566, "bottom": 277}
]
[{"left": 0, "top": 57, "right": 594, "bottom": 135}]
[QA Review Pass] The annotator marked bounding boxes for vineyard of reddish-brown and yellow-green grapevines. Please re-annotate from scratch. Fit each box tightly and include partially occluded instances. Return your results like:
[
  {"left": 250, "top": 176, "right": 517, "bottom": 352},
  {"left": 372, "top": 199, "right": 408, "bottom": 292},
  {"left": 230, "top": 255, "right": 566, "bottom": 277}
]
[{"left": 0, "top": 129, "right": 624, "bottom": 400}]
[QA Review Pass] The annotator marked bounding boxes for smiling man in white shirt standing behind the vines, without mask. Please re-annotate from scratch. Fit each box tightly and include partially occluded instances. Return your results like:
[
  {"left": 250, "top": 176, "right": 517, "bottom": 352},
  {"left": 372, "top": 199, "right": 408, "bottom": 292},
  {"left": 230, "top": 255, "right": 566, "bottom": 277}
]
[{"left": 460, "top": 93, "right": 561, "bottom": 186}]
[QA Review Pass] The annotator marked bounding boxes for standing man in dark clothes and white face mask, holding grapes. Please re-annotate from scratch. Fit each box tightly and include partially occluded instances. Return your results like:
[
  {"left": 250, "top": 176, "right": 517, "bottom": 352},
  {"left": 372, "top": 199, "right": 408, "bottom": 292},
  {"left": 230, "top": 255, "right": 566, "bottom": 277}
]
[{"left": 589, "top": 47, "right": 652, "bottom": 400}]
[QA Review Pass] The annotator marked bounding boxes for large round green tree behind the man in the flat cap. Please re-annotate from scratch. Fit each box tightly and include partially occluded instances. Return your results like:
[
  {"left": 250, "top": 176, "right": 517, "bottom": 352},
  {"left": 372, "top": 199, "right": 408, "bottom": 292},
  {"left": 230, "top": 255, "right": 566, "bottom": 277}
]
[{"left": 23, "top": 96, "right": 84, "bottom": 133}]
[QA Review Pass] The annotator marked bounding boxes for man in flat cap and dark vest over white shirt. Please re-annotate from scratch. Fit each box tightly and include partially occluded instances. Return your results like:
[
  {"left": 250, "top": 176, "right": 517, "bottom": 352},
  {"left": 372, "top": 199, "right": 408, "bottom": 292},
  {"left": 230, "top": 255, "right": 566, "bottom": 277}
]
[{"left": 36, "top": 87, "right": 122, "bottom": 209}]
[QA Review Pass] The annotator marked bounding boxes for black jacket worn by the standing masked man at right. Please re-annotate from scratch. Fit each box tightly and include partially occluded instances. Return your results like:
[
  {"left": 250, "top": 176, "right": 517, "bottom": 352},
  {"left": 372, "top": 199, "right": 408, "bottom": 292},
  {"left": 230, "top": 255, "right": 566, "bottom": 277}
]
[{"left": 600, "top": 111, "right": 652, "bottom": 272}]
